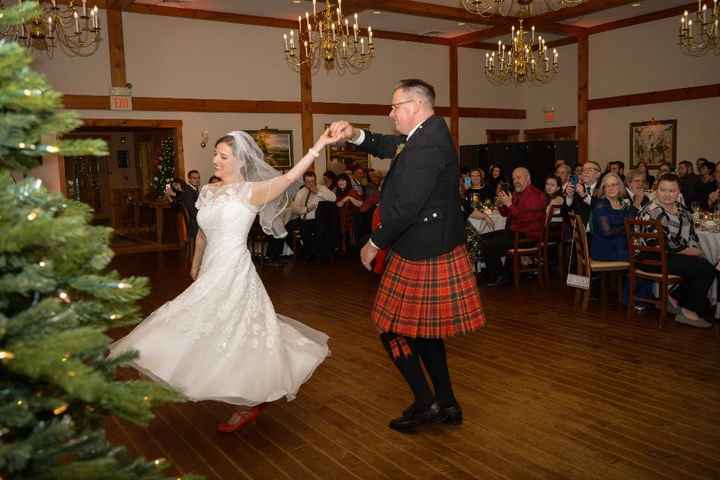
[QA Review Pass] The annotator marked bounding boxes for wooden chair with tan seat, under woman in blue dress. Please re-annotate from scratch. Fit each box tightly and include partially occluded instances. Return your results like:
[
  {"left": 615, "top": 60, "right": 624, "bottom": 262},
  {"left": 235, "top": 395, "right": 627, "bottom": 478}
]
[{"left": 570, "top": 212, "right": 630, "bottom": 312}]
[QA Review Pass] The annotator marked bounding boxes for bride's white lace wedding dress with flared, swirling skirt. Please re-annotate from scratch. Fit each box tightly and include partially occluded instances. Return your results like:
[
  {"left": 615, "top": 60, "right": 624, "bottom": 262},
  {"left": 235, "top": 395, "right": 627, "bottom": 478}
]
[{"left": 110, "top": 182, "right": 330, "bottom": 406}]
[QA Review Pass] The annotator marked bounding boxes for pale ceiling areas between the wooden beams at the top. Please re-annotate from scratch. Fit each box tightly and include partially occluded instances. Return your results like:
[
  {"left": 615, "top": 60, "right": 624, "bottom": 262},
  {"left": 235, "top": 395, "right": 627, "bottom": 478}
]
[{"left": 136, "top": 0, "right": 690, "bottom": 41}]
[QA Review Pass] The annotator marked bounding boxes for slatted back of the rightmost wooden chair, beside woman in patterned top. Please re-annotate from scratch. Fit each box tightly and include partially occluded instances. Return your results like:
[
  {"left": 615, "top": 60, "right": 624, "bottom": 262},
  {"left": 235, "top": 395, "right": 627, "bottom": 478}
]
[{"left": 625, "top": 219, "right": 668, "bottom": 282}]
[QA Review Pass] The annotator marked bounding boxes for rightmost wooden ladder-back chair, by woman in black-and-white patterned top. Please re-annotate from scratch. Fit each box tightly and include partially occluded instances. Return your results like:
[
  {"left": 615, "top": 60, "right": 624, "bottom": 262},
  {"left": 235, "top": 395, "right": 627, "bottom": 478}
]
[{"left": 625, "top": 220, "right": 682, "bottom": 328}]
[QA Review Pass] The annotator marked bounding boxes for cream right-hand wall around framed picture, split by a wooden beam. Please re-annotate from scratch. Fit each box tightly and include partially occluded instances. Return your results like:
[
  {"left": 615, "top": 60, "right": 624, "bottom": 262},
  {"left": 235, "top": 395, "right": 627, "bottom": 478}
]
[{"left": 588, "top": 17, "right": 720, "bottom": 167}]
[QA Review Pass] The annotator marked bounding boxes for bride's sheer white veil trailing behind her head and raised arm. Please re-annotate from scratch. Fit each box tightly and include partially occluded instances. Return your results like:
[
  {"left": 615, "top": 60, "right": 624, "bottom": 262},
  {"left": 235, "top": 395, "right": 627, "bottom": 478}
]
[{"left": 215, "top": 131, "right": 300, "bottom": 238}]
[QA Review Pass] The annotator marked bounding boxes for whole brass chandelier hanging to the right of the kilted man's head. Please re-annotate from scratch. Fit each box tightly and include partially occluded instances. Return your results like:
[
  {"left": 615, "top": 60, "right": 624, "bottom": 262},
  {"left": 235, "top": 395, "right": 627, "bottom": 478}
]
[{"left": 483, "top": 19, "right": 560, "bottom": 84}]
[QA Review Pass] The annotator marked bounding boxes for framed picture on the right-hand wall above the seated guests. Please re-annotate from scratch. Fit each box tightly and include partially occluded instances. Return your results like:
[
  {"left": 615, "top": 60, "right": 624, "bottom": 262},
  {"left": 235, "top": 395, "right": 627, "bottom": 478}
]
[{"left": 630, "top": 120, "right": 677, "bottom": 169}]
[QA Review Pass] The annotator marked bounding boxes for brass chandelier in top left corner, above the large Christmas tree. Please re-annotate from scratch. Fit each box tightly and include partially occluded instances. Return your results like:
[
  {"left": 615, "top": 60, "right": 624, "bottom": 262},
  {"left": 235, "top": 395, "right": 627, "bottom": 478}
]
[{"left": 0, "top": 0, "right": 100, "bottom": 58}]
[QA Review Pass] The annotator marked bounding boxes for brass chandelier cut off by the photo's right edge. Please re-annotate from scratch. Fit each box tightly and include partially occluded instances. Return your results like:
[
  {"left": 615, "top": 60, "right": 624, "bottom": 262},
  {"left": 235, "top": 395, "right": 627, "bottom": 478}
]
[{"left": 679, "top": 0, "right": 720, "bottom": 56}]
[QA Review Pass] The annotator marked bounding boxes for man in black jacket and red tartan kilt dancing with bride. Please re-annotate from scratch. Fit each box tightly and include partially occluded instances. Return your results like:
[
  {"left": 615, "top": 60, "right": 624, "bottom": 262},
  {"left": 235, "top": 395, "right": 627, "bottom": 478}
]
[{"left": 330, "top": 79, "right": 485, "bottom": 432}]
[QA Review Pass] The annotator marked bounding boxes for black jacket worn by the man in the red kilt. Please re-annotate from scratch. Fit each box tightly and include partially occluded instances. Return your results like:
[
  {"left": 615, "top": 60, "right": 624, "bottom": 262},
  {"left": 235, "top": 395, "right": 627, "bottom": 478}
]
[{"left": 360, "top": 116, "right": 465, "bottom": 260}]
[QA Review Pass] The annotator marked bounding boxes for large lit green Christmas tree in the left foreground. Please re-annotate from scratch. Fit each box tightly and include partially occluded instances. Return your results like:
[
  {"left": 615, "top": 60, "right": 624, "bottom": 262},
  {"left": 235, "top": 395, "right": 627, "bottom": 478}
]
[{"left": 0, "top": 2, "right": 197, "bottom": 480}]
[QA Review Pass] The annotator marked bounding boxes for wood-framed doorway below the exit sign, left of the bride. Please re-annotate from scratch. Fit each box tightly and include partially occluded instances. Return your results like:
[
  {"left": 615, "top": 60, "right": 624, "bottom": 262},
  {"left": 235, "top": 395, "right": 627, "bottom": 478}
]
[{"left": 61, "top": 119, "right": 185, "bottom": 253}]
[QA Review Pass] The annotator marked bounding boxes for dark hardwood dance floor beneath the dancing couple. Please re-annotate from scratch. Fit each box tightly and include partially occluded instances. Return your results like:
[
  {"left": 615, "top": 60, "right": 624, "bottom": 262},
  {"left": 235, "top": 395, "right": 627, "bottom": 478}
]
[{"left": 107, "top": 253, "right": 720, "bottom": 480}]
